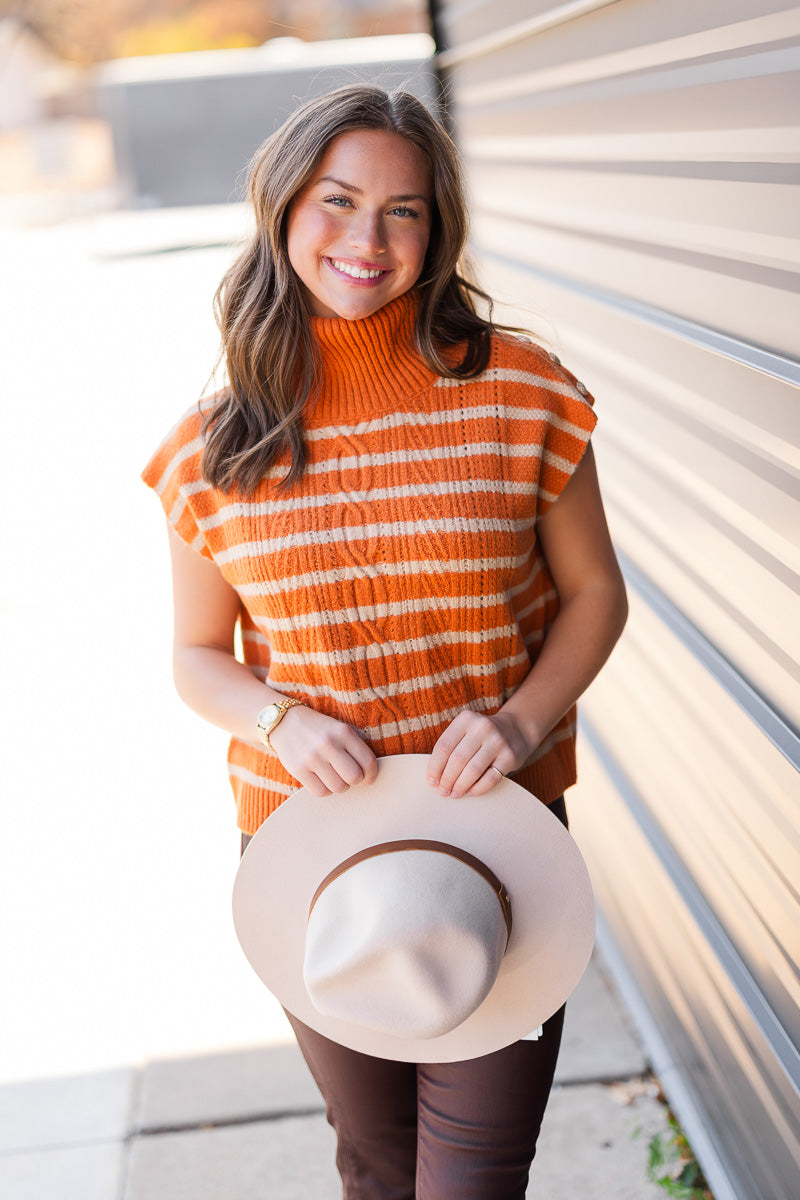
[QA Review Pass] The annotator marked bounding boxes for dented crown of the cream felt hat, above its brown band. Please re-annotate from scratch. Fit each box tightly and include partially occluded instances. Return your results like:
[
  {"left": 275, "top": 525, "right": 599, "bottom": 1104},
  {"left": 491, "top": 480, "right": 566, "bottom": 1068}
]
[{"left": 303, "top": 847, "right": 507, "bottom": 1039}]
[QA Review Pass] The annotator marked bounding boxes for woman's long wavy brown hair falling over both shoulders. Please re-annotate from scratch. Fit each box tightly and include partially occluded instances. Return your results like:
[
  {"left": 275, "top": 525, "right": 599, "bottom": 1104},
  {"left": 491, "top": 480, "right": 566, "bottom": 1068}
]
[{"left": 203, "top": 84, "right": 506, "bottom": 492}]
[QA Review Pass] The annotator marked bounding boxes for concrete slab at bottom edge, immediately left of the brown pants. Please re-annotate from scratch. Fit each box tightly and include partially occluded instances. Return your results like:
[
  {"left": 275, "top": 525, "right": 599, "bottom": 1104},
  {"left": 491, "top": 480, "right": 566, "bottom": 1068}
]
[{"left": 122, "top": 1116, "right": 338, "bottom": 1200}]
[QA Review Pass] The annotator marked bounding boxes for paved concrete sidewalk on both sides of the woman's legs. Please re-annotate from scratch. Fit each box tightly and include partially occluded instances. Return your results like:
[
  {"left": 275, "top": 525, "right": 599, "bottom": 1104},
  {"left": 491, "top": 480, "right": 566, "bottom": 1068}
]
[{"left": 0, "top": 956, "right": 666, "bottom": 1200}]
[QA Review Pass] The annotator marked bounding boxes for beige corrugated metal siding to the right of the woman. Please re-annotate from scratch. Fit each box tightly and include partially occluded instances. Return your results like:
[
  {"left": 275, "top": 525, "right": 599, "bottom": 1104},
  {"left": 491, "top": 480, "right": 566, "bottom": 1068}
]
[{"left": 433, "top": 0, "right": 800, "bottom": 1200}]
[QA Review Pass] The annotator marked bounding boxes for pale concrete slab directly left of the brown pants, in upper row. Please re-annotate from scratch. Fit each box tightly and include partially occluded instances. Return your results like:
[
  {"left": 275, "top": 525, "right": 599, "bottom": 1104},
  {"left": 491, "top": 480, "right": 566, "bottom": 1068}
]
[{"left": 137, "top": 1044, "right": 324, "bottom": 1130}]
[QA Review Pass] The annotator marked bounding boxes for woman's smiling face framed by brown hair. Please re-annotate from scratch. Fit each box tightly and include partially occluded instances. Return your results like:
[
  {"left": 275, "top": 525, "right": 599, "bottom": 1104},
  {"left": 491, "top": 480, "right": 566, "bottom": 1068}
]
[{"left": 287, "top": 130, "right": 433, "bottom": 320}]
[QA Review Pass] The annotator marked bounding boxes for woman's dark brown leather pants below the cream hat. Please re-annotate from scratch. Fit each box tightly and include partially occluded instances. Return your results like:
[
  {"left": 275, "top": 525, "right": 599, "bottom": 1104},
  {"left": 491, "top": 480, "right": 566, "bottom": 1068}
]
[{"left": 242, "top": 798, "right": 567, "bottom": 1200}]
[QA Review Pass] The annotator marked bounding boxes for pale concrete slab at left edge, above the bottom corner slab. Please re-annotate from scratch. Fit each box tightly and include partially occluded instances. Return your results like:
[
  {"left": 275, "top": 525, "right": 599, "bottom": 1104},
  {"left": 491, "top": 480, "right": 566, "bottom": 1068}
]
[{"left": 0, "top": 1069, "right": 138, "bottom": 1153}]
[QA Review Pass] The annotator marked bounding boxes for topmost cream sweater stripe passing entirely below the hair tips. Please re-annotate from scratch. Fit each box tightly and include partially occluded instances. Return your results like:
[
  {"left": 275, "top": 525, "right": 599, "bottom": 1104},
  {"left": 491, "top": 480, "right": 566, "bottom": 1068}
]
[{"left": 194, "top": 479, "right": 536, "bottom": 529}]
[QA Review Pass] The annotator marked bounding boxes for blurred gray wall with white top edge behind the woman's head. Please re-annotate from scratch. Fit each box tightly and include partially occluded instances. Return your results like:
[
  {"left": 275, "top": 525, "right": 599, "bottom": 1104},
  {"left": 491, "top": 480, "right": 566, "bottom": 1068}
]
[{"left": 95, "top": 34, "right": 437, "bottom": 206}]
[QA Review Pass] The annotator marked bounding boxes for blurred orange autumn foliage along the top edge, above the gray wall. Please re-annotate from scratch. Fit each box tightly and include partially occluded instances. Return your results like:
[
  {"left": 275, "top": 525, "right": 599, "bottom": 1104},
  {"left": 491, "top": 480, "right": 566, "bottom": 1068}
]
[{"left": 0, "top": 0, "right": 428, "bottom": 66}]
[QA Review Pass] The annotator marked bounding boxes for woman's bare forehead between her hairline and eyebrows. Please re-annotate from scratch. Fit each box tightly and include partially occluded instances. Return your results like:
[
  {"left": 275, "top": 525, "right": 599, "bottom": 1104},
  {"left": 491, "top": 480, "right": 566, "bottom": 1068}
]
[{"left": 312, "top": 130, "right": 431, "bottom": 196}]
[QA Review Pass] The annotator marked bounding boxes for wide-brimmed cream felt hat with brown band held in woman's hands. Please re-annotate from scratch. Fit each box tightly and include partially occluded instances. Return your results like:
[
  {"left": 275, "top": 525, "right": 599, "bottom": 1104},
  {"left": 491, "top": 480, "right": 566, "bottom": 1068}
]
[{"left": 233, "top": 755, "right": 595, "bottom": 1062}]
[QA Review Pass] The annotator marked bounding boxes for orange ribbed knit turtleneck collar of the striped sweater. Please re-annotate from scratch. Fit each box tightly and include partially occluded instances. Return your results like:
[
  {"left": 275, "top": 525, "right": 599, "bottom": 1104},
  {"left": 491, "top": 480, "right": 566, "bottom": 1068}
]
[{"left": 309, "top": 292, "right": 437, "bottom": 425}]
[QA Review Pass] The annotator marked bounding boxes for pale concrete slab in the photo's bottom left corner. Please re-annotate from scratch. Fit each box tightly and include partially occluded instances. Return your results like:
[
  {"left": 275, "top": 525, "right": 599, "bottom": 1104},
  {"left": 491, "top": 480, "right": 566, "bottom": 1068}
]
[{"left": 0, "top": 1142, "right": 125, "bottom": 1200}]
